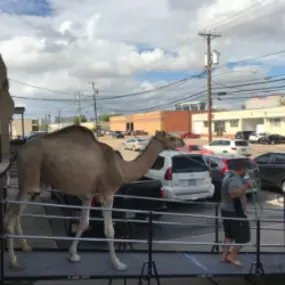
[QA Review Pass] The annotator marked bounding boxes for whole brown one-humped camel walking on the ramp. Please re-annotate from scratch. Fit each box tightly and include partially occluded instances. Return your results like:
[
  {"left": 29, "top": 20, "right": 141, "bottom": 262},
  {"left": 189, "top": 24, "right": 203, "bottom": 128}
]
[{"left": 2, "top": 125, "right": 176, "bottom": 270}]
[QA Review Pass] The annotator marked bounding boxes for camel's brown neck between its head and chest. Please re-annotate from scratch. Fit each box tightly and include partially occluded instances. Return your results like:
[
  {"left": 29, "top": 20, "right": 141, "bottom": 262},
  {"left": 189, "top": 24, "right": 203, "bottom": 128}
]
[{"left": 119, "top": 139, "right": 163, "bottom": 183}]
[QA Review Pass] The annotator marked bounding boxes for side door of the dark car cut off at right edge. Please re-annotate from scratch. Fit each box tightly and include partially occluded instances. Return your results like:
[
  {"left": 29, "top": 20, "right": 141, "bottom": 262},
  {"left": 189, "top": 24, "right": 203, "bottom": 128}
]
[{"left": 267, "top": 153, "right": 285, "bottom": 187}]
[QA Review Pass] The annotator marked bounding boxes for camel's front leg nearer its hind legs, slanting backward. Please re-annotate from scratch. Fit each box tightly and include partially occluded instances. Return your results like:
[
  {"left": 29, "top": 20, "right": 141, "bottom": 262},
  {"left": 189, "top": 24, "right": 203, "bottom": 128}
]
[{"left": 69, "top": 199, "right": 92, "bottom": 262}]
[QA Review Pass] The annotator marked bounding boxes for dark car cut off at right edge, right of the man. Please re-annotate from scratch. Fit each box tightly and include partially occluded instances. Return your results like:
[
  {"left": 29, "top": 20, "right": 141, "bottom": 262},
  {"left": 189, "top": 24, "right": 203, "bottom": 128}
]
[{"left": 254, "top": 152, "right": 285, "bottom": 191}]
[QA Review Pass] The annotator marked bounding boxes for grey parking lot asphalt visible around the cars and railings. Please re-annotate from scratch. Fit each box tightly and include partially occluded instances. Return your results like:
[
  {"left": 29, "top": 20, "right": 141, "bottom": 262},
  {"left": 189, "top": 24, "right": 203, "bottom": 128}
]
[{"left": 5, "top": 136, "right": 285, "bottom": 285}]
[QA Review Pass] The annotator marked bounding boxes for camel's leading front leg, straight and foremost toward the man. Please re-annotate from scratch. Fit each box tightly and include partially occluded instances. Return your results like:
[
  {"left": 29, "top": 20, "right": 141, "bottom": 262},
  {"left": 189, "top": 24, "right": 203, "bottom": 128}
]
[{"left": 102, "top": 201, "right": 128, "bottom": 271}]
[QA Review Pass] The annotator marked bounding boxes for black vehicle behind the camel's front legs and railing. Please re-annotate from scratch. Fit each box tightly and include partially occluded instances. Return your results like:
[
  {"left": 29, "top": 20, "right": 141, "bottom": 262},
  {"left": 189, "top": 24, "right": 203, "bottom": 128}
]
[{"left": 53, "top": 177, "right": 168, "bottom": 235}]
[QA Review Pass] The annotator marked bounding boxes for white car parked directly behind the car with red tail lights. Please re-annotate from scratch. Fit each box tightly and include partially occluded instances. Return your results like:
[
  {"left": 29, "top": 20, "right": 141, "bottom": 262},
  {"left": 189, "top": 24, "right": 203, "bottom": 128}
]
[{"left": 204, "top": 139, "right": 252, "bottom": 156}]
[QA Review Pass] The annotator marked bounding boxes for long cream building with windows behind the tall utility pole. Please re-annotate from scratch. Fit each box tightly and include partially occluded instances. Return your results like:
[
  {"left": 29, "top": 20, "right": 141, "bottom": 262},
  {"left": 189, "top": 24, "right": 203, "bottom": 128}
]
[{"left": 192, "top": 106, "right": 285, "bottom": 137}]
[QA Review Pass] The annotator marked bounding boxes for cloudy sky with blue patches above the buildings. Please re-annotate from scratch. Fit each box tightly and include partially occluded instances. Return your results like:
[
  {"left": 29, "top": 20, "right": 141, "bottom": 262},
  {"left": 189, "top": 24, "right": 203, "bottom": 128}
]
[{"left": 0, "top": 0, "right": 285, "bottom": 119}]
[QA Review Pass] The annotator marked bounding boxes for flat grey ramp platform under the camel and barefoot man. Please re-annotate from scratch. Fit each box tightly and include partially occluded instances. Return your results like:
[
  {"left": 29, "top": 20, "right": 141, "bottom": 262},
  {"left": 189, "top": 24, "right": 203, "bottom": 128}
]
[{"left": 4, "top": 250, "right": 285, "bottom": 281}]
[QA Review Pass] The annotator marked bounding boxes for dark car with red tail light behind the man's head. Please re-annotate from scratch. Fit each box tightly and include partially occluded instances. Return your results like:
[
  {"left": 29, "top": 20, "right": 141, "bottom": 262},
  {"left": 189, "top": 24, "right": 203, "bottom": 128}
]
[{"left": 204, "top": 154, "right": 261, "bottom": 200}]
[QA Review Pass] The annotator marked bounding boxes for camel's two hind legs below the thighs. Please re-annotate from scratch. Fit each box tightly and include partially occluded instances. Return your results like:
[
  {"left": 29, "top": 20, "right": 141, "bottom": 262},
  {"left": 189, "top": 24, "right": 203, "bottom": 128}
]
[{"left": 5, "top": 193, "right": 31, "bottom": 270}]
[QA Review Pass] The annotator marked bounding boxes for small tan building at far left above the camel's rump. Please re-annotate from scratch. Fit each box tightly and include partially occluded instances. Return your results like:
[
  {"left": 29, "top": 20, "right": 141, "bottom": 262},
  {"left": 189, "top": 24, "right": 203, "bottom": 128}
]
[{"left": 10, "top": 116, "right": 40, "bottom": 138}]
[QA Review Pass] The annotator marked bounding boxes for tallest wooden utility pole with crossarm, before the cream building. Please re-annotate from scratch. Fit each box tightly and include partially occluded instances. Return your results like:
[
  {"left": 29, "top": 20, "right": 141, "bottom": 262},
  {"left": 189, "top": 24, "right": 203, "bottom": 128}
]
[{"left": 199, "top": 31, "right": 221, "bottom": 143}]
